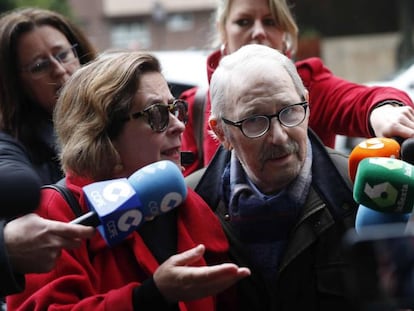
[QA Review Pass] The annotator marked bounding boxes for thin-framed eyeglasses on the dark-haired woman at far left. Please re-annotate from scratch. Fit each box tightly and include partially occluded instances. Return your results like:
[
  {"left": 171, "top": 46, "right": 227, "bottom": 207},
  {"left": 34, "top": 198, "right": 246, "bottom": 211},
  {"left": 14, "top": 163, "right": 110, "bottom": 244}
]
[{"left": 21, "top": 44, "right": 78, "bottom": 79}]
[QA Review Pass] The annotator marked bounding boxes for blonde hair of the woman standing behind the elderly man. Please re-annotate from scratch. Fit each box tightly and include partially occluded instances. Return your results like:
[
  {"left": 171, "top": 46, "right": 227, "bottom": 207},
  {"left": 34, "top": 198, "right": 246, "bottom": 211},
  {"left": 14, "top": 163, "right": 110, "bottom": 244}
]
[{"left": 213, "top": 0, "right": 299, "bottom": 56}]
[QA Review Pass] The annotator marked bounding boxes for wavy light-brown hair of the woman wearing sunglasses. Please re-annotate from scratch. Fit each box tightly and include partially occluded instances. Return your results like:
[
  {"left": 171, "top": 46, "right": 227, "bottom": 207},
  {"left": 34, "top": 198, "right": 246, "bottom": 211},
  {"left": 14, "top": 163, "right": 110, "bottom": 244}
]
[{"left": 54, "top": 51, "right": 161, "bottom": 180}]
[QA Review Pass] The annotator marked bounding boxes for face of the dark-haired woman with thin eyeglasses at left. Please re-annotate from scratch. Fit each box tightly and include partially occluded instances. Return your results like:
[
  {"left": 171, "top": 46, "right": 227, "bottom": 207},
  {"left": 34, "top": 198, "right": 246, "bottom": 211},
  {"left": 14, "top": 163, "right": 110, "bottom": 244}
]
[{"left": 17, "top": 26, "right": 80, "bottom": 113}]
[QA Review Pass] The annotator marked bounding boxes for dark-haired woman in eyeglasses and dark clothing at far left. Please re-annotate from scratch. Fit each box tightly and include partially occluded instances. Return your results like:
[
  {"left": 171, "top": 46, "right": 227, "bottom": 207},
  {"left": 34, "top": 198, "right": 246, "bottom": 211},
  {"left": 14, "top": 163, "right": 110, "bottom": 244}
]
[{"left": 0, "top": 8, "right": 96, "bottom": 184}]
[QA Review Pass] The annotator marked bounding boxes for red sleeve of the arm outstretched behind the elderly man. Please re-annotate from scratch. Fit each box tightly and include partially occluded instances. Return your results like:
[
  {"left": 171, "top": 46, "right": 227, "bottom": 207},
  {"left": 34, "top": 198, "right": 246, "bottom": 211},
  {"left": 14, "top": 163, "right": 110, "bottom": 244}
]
[{"left": 296, "top": 57, "right": 414, "bottom": 147}]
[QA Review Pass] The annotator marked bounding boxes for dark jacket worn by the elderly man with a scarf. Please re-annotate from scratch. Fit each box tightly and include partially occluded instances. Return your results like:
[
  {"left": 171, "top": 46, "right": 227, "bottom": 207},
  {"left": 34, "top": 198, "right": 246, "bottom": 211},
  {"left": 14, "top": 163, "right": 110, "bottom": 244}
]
[{"left": 188, "top": 131, "right": 357, "bottom": 311}]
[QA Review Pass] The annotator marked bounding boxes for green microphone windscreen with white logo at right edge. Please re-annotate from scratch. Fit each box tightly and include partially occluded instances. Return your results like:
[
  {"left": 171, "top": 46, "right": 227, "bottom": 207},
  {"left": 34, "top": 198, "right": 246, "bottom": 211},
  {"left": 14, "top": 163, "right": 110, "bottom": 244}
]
[{"left": 354, "top": 157, "right": 414, "bottom": 213}]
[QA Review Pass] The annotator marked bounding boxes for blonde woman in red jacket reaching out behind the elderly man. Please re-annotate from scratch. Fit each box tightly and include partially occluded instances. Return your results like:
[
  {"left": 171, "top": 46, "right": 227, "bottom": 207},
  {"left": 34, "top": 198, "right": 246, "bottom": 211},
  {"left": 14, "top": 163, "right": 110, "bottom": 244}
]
[{"left": 180, "top": 0, "right": 414, "bottom": 175}]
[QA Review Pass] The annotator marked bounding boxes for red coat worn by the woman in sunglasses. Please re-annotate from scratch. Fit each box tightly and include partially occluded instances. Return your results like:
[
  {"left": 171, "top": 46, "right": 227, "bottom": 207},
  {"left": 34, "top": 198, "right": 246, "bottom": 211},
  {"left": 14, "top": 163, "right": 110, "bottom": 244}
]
[{"left": 7, "top": 185, "right": 222, "bottom": 311}]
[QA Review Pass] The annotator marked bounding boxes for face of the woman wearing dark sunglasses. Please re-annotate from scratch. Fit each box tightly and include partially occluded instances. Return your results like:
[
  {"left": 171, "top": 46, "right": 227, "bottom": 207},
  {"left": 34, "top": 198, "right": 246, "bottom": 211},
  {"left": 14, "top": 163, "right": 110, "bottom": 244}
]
[{"left": 113, "top": 72, "right": 185, "bottom": 176}]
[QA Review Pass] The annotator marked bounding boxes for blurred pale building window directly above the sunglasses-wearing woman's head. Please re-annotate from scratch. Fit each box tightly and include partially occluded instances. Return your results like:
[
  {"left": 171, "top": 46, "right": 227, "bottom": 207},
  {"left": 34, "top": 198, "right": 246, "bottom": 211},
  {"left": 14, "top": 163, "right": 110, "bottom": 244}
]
[{"left": 111, "top": 22, "right": 151, "bottom": 50}]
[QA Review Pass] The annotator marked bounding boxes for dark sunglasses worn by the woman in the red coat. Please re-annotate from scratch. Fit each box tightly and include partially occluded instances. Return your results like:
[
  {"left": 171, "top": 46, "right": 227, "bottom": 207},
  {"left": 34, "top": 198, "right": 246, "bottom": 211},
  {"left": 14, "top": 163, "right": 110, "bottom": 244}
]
[{"left": 126, "top": 99, "right": 188, "bottom": 132}]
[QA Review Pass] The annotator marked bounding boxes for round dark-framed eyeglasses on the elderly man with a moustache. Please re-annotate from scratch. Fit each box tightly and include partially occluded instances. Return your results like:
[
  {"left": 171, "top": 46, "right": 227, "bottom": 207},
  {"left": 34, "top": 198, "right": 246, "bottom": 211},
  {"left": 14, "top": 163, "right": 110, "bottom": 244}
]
[{"left": 221, "top": 101, "right": 308, "bottom": 138}]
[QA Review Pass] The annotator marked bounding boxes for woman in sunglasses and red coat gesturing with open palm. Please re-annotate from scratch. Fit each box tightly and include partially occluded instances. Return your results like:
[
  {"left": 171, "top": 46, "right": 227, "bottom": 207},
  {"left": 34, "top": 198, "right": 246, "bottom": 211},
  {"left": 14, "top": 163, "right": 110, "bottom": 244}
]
[{"left": 7, "top": 51, "right": 250, "bottom": 311}]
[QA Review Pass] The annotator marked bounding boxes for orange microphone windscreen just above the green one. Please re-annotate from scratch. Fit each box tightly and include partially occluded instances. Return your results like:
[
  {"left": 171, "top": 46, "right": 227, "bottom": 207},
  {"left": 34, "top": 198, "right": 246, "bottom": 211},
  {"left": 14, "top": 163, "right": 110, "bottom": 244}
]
[{"left": 348, "top": 137, "right": 400, "bottom": 182}]
